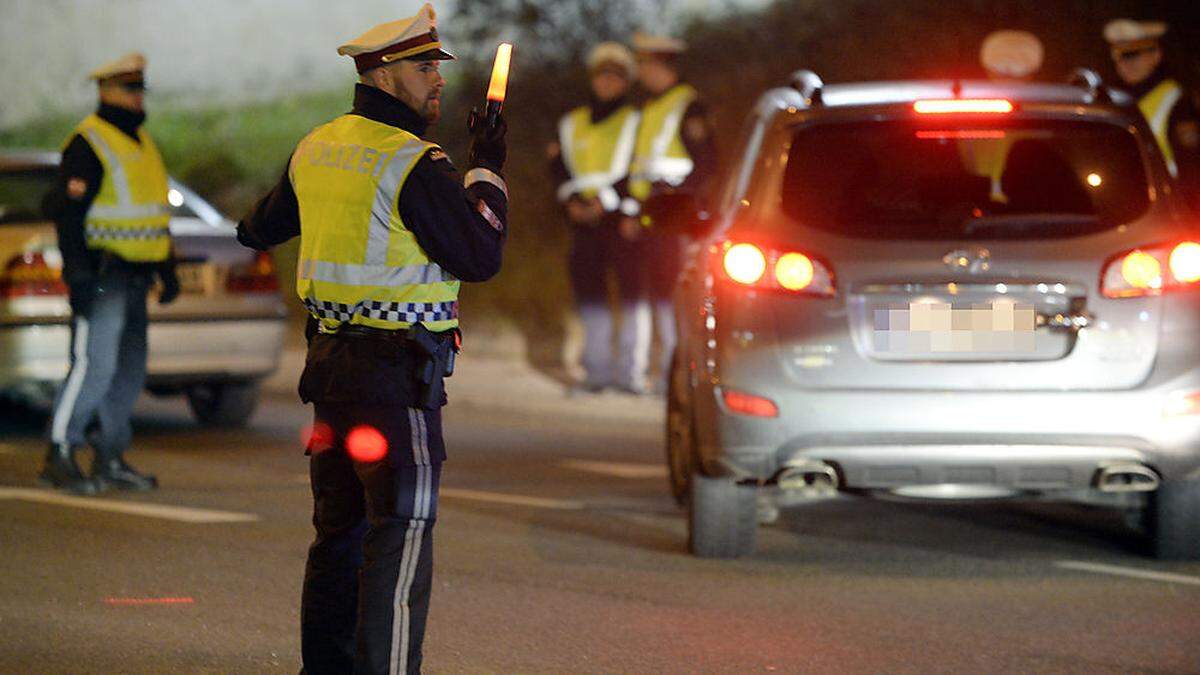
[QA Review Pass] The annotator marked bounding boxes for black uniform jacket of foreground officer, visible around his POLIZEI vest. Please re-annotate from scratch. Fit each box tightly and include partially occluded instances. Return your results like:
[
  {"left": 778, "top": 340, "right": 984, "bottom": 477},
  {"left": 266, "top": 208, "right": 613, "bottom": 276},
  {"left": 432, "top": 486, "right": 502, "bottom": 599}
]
[{"left": 238, "top": 84, "right": 508, "bottom": 406}]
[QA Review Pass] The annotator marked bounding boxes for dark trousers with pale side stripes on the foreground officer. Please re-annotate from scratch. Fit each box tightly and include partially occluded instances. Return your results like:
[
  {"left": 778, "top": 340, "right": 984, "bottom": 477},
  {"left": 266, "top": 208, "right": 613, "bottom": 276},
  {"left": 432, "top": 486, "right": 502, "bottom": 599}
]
[{"left": 300, "top": 402, "right": 445, "bottom": 675}]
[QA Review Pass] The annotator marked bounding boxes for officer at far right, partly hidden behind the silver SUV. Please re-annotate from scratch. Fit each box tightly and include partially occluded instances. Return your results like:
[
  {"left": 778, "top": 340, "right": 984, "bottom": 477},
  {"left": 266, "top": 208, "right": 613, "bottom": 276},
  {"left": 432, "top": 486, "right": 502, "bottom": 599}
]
[{"left": 1104, "top": 19, "right": 1200, "bottom": 208}]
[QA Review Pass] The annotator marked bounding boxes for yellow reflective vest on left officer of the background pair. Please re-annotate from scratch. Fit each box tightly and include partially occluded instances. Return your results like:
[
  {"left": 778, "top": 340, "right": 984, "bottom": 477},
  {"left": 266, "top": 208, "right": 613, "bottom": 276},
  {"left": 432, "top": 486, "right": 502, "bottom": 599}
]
[{"left": 558, "top": 106, "right": 640, "bottom": 211}]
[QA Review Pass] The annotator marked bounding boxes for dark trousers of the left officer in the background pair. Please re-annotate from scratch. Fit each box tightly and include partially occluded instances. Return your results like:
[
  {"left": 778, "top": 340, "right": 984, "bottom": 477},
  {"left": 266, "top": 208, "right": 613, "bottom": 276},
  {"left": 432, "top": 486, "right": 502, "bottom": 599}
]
[{"left": 568, "top": 217, "right": 650, "bottom": 388}]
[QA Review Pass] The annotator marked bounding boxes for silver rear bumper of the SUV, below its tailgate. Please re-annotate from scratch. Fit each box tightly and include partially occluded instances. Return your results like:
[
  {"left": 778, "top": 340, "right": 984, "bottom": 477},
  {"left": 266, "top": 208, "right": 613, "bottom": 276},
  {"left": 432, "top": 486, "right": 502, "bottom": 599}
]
[{"left": 696, "top": 371, "right": 1200, "bottom": 482}]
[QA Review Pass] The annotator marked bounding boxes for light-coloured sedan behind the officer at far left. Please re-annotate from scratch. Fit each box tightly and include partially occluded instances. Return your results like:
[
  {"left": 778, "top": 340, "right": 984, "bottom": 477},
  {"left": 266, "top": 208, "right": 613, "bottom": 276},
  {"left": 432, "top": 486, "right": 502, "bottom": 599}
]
[{"left": 0, "top": 151, "right": 286, "bottom": 425}]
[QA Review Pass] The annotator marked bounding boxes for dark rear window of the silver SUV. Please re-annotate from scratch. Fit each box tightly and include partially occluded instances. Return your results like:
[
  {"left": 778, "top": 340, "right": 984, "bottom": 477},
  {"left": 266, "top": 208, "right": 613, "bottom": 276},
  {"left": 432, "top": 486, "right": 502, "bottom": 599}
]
[{"left": 782, "top": 119, "right": 1150, "bottom": 239}]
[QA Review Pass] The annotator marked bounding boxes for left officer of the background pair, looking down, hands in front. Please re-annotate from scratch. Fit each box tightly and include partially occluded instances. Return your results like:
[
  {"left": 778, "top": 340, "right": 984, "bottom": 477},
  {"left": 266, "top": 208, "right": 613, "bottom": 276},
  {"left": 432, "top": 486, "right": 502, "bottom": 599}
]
[{"left": 550, "top": 42, "right": 650, "bottom": 394}]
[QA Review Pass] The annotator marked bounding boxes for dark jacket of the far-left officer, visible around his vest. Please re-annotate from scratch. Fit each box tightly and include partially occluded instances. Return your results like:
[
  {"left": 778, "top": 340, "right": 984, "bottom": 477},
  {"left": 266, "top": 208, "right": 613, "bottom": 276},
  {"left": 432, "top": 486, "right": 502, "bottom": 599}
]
[{"left": 42, "top": 104, "right": 174, "bottom": 286}]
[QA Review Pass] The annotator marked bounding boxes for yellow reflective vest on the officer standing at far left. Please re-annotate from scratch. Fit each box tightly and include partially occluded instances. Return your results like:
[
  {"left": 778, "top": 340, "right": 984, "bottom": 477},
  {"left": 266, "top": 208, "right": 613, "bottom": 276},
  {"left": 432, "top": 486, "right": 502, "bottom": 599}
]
[{"left": 76, "top": 114, "right": 170, "bottom": 263}]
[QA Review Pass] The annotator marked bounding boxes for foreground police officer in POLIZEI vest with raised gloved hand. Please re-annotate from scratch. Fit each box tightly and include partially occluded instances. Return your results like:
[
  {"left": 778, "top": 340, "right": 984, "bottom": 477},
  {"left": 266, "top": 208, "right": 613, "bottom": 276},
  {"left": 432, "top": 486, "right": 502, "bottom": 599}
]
[{"left": 238, "top": 5, "right": 508, "bottom": 675}]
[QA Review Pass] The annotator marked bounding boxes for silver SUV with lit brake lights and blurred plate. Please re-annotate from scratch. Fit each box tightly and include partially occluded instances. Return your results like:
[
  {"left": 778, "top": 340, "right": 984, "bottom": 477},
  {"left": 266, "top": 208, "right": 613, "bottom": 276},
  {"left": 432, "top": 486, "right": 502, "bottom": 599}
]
[{"left": 667, "top": 71, "right": 1200, "bottom": 560}]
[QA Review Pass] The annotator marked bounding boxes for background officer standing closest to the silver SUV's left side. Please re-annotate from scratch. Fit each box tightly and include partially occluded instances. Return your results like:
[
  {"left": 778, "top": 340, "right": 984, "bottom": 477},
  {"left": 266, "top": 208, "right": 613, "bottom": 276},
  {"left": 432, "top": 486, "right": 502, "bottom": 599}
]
[{"left": 622, "top": 34, "right": 716, "bottom": 392}]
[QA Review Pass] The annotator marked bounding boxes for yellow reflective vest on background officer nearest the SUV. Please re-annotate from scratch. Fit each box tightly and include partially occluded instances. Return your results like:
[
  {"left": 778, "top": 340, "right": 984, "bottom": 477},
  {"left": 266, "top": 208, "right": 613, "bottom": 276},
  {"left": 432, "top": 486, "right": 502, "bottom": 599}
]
[{"left": 629, "top": 84, "right": 697, "bottom": 201}]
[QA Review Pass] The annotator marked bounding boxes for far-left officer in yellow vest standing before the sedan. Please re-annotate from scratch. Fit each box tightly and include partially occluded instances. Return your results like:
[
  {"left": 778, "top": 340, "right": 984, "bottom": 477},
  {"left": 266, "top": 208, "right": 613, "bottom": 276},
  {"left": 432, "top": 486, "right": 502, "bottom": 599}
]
[{"left": 41, "top": 54, "right": 179, "bottom": 495}]
